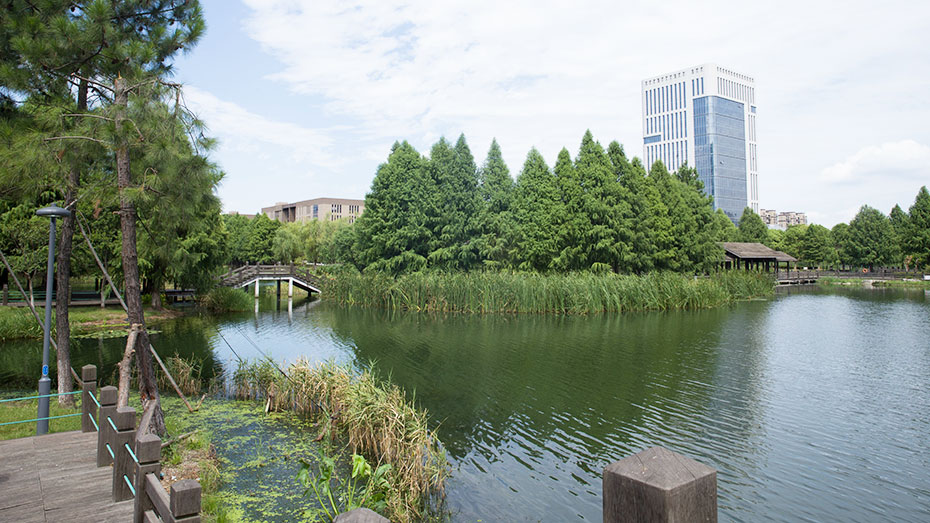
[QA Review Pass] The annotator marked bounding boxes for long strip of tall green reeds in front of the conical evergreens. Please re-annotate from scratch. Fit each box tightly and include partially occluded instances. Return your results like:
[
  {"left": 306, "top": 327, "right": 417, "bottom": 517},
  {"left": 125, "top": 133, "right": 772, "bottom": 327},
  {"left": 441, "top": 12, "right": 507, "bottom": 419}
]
[{"left": 327, "top": 271, "right": 774, "bottom": 314}]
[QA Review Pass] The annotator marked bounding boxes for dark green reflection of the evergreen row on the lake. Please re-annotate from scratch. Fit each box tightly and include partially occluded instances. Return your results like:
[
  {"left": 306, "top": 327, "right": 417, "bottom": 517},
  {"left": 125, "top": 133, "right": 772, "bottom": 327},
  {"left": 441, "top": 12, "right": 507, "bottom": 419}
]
[{"left": 322, "top": 309, "right": 726, "bottom": 460}]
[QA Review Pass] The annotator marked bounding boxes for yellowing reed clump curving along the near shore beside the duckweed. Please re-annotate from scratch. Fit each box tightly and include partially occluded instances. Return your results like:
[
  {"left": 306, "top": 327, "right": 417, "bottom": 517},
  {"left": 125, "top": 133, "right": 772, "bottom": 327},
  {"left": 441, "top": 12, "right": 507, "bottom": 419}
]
[{"left": 233, "top": 360, "right": 449, "bottom": 522}]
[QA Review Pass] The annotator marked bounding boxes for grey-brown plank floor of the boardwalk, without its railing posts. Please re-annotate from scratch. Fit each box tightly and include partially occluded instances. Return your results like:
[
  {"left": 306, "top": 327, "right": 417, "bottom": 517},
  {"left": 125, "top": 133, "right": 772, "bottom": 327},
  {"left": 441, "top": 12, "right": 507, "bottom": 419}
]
[{"left": 0, "top": 432, "right": 133, "bottom": 523}]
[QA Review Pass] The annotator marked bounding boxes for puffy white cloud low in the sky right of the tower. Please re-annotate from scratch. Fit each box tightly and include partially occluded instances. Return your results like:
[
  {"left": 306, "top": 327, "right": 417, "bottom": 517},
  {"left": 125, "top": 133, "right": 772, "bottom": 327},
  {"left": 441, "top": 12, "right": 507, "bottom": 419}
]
[{"left": 820, "top": 140, "right": 930, "bottom": 183}]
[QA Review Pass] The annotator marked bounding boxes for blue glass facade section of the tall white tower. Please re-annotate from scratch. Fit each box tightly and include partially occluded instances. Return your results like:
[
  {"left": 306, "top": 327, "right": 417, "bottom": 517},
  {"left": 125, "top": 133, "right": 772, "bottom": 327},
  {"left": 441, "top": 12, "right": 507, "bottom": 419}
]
[{"left": 694, "top": 96, "right": 747, "bottom": 223}]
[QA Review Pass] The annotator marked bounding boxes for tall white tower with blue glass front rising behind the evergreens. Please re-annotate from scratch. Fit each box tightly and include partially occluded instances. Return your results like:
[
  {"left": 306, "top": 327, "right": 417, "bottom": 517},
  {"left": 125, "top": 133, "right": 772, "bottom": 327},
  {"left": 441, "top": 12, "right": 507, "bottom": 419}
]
[{"left": 642, "top": 64, "right": 759, "bottom": 223}]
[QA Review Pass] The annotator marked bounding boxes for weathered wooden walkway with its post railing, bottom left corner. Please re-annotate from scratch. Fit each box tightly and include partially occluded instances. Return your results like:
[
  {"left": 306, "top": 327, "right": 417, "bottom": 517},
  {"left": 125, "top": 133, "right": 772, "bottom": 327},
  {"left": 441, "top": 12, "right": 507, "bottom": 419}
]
[{"left": 0, "top": 365, "right": 201, "bottom": 523}]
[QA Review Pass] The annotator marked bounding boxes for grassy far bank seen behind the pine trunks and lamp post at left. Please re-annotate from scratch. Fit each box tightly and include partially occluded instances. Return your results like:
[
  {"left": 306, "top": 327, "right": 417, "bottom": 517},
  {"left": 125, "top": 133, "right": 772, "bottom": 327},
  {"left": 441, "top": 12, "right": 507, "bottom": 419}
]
[{"left": 0, "top": 307, "right": 181, "bottom": 341}]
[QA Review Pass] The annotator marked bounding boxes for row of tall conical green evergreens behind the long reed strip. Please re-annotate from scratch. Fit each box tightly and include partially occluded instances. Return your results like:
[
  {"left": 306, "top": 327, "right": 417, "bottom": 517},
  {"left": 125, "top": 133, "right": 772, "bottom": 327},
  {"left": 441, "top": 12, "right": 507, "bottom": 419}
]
[{"left": 335, "top": 131, "right": 735, "bottom": 275}]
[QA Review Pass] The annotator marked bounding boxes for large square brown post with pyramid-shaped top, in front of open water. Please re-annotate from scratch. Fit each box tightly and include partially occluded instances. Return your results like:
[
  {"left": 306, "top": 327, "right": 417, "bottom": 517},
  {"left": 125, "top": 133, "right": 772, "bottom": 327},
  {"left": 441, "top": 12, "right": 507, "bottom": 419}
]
[{"left": 603, "top": 447, "right": 717, "bottom": 523}]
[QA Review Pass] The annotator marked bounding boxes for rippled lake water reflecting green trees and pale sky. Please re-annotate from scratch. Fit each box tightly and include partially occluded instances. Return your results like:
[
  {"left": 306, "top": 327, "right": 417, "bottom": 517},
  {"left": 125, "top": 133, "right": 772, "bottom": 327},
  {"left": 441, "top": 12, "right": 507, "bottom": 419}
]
[{"left": 0, "top": 288, "right": 930, "bottom": 521}]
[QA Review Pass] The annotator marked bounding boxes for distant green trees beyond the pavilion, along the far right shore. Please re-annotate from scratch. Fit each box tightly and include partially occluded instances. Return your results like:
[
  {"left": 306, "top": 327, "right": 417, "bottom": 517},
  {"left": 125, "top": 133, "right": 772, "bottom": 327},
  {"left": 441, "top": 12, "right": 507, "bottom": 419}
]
[{"left": 728, "top": 186, "right": 930, "bottom": 270}]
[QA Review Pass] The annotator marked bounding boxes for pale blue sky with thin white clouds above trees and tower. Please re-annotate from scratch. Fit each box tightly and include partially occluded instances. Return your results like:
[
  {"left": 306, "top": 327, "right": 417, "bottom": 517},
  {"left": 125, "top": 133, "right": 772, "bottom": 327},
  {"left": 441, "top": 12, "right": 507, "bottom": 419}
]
[{"left": 174, "top": 0, "right": 930, "bottom": 227}]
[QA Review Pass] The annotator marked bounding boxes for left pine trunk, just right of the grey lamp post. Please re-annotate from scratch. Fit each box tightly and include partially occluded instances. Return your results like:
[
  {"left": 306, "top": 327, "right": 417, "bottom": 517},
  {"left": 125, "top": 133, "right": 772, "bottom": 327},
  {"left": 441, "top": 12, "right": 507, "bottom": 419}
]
[{"left": 55, "top": 75, "right": 87, "bottom": 407}]
